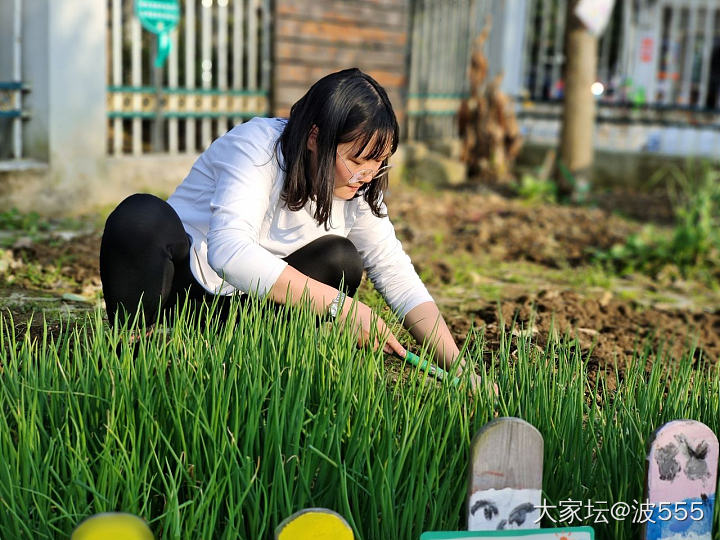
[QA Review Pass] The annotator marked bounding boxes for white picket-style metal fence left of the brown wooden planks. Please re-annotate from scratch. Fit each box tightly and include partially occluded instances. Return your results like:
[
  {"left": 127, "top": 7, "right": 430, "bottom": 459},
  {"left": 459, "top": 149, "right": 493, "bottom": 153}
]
[{"left": 108, "top": 0, "right": 271, "bottom": 155}]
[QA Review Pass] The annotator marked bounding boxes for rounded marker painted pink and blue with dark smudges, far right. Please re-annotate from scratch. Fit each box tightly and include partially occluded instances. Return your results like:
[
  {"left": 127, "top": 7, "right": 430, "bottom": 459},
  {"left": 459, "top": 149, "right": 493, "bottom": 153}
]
[{"left": 645, "top": 420, "right": 718, "bottom": 540}]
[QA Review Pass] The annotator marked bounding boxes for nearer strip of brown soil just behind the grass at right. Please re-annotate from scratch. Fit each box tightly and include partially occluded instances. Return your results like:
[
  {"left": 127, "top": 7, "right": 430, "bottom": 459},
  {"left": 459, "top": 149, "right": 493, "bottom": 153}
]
[{"left": 449, "top": 290, "right": 720, "bottom": 365}]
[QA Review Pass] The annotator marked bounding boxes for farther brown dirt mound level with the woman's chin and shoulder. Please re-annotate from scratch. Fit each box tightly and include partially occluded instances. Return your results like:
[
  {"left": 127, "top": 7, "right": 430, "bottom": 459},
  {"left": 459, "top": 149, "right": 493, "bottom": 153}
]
[{"left": 389, "top": 191, "right": 640, "bottom": 268}]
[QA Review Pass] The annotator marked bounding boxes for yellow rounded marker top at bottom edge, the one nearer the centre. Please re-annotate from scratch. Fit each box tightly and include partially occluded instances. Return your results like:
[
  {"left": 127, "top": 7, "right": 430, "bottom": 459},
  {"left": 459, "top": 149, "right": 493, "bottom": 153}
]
[{"left": 275, "top": 508, "right": 354, "bottom": 540}]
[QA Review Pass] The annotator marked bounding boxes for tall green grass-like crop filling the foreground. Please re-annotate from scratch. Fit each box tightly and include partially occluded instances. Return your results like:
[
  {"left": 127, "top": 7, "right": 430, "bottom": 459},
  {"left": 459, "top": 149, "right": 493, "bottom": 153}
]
[{"left": 0, "top": 298, "right": 720, "bottom": 540}]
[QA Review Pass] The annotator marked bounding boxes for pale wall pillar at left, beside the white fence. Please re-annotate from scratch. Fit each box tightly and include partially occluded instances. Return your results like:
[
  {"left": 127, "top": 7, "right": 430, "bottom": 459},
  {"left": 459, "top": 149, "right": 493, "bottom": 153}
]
[{"left": 0, "top": 0, "right": 107, "bottom": 213}]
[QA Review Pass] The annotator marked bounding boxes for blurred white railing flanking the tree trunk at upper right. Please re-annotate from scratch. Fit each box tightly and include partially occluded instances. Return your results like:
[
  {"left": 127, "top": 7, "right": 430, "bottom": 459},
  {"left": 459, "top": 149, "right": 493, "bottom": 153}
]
[{"left": 524, "top": 0, "right": 720, "bottom": 109}]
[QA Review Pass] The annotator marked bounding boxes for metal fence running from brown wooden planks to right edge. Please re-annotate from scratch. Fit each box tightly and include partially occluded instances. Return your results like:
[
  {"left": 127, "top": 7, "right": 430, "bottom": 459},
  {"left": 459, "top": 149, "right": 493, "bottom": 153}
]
[{"left": 408, "top": 0, "right": 720, "bottom": 139}]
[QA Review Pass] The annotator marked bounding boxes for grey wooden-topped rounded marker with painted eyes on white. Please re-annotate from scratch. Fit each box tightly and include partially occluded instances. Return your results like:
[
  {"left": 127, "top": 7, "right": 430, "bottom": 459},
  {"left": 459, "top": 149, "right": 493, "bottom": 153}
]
[{"left": 467, "top": 418, "right": 543, "bottom": 531}]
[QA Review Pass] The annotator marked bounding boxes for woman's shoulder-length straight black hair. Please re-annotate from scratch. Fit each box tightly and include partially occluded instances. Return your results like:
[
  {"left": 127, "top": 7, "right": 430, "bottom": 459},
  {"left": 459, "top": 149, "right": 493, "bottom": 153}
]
[{"left": 278, "top": 68, "right": 399, "bottom": 228}]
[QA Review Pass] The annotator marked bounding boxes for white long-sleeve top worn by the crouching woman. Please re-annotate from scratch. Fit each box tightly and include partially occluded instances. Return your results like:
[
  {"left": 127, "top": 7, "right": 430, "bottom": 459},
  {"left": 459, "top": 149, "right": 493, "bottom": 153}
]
[{"left": 168, "top": 118, "right": 432, "bottom": 317}]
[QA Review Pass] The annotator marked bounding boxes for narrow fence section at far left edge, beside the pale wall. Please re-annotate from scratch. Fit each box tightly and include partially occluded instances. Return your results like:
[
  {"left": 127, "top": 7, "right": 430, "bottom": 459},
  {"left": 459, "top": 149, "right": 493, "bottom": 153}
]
[{"left": 0, "top": 0, "right": 28, "bottom": 160}]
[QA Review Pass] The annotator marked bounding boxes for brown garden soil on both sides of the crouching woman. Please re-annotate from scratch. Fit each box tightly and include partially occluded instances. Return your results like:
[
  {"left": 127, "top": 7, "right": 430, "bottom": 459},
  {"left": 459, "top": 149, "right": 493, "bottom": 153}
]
[{"left": 0, "top": 187, "right": 720, "bottom": 367}]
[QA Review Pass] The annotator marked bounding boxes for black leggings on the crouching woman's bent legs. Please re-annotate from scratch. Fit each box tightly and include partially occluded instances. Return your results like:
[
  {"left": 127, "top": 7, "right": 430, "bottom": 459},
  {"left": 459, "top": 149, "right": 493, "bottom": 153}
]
[{"left": 100, "top": 193, "right": 363, "bottom": 325}]
